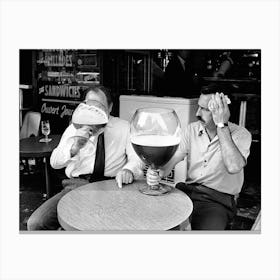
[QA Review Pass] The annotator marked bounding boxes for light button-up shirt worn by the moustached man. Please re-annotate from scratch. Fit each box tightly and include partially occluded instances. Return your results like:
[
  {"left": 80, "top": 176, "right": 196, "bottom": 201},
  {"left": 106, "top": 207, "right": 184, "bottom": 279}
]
[{"left": 178, "top": 122, "right": 252, "bottom": 195}]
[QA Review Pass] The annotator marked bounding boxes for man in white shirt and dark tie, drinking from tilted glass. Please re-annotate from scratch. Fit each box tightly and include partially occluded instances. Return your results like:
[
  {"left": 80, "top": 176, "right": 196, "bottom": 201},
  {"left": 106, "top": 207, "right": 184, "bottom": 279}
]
[{"left": 27, "top": 86, "right": 143, "bottom": 230}]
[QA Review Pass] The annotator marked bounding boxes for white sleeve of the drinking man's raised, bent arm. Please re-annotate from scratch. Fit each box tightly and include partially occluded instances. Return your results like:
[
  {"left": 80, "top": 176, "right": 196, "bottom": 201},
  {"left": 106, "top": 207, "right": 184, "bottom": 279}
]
[{"left": 50, "top": 124, "right": 76, "bottom": 169}]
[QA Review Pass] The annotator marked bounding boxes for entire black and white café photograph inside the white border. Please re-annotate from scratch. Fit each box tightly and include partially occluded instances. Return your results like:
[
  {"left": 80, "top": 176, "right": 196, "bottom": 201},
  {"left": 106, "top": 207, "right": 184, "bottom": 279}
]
[{"left": 19, "top": 49, "right": 261, "bottom": 233}]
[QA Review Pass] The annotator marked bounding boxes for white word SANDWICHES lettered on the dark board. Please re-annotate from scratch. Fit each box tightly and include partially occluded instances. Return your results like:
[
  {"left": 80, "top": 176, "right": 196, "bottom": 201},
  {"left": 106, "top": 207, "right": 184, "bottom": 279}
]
[{"left": 44, "top": 85, "right": 81, "bottom": 99}]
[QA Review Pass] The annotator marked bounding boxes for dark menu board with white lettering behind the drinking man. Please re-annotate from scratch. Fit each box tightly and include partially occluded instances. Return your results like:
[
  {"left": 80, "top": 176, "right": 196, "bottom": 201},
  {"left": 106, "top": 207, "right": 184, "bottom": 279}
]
[{"left": 37, "top": 49, "right": 101, "bottom": 133}]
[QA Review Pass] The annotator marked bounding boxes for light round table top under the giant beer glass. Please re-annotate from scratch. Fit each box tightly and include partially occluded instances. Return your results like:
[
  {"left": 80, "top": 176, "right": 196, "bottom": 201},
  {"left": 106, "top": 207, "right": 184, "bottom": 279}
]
[{"left": 57, "top": 180, "right": 193, "bottom": 231}]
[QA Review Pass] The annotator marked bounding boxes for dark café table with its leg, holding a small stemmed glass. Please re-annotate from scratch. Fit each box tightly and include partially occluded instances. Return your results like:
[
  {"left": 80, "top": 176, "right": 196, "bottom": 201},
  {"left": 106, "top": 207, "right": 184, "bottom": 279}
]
[{"left": 20, "top": 135, "right": 61, "bottom": 198}]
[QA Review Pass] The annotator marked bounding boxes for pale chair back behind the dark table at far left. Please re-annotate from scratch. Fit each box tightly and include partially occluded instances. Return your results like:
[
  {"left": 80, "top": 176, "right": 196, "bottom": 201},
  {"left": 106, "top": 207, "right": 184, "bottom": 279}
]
[{"left": 20, "top": 111, "right": 41, "bottom": 139}]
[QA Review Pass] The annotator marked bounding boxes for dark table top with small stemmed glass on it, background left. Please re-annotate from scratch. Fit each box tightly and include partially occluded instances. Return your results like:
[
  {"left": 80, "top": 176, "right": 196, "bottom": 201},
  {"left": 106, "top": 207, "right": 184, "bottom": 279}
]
[{"left": 20, "top": 135, "right": 61, "bottom": 157}]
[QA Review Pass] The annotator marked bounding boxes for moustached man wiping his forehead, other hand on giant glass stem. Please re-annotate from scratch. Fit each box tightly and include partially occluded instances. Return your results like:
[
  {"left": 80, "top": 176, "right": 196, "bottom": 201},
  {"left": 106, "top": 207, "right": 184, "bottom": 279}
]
[{"left": 147, "top": 85, "right": 251, "bottom": 230}]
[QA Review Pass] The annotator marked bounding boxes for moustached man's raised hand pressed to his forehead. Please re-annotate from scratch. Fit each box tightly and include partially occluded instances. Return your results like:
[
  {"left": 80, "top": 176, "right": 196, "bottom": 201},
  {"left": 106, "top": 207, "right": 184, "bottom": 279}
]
[{"left": 208, "top": 92, "right": 230, "bottom": 125}]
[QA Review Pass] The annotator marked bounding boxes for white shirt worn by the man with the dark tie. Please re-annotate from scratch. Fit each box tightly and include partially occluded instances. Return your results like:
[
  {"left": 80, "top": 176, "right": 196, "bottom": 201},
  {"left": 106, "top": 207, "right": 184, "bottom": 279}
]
[{"left": 50, "top": 116, "right": 144, "bottom": 178}]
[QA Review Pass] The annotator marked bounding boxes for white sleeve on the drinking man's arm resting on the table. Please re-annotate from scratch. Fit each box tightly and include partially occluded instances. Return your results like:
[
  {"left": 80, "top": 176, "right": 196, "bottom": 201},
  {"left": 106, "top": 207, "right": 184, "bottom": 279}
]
[{"left": 122, "top": 123, "right": 145, "bottom": 179}]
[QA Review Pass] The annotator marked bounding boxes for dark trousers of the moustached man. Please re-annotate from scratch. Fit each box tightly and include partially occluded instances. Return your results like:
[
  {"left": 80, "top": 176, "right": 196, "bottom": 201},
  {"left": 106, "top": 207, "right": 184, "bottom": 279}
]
[{"left": 176, "top": 183, "right": 236, "bottom": 230}]
